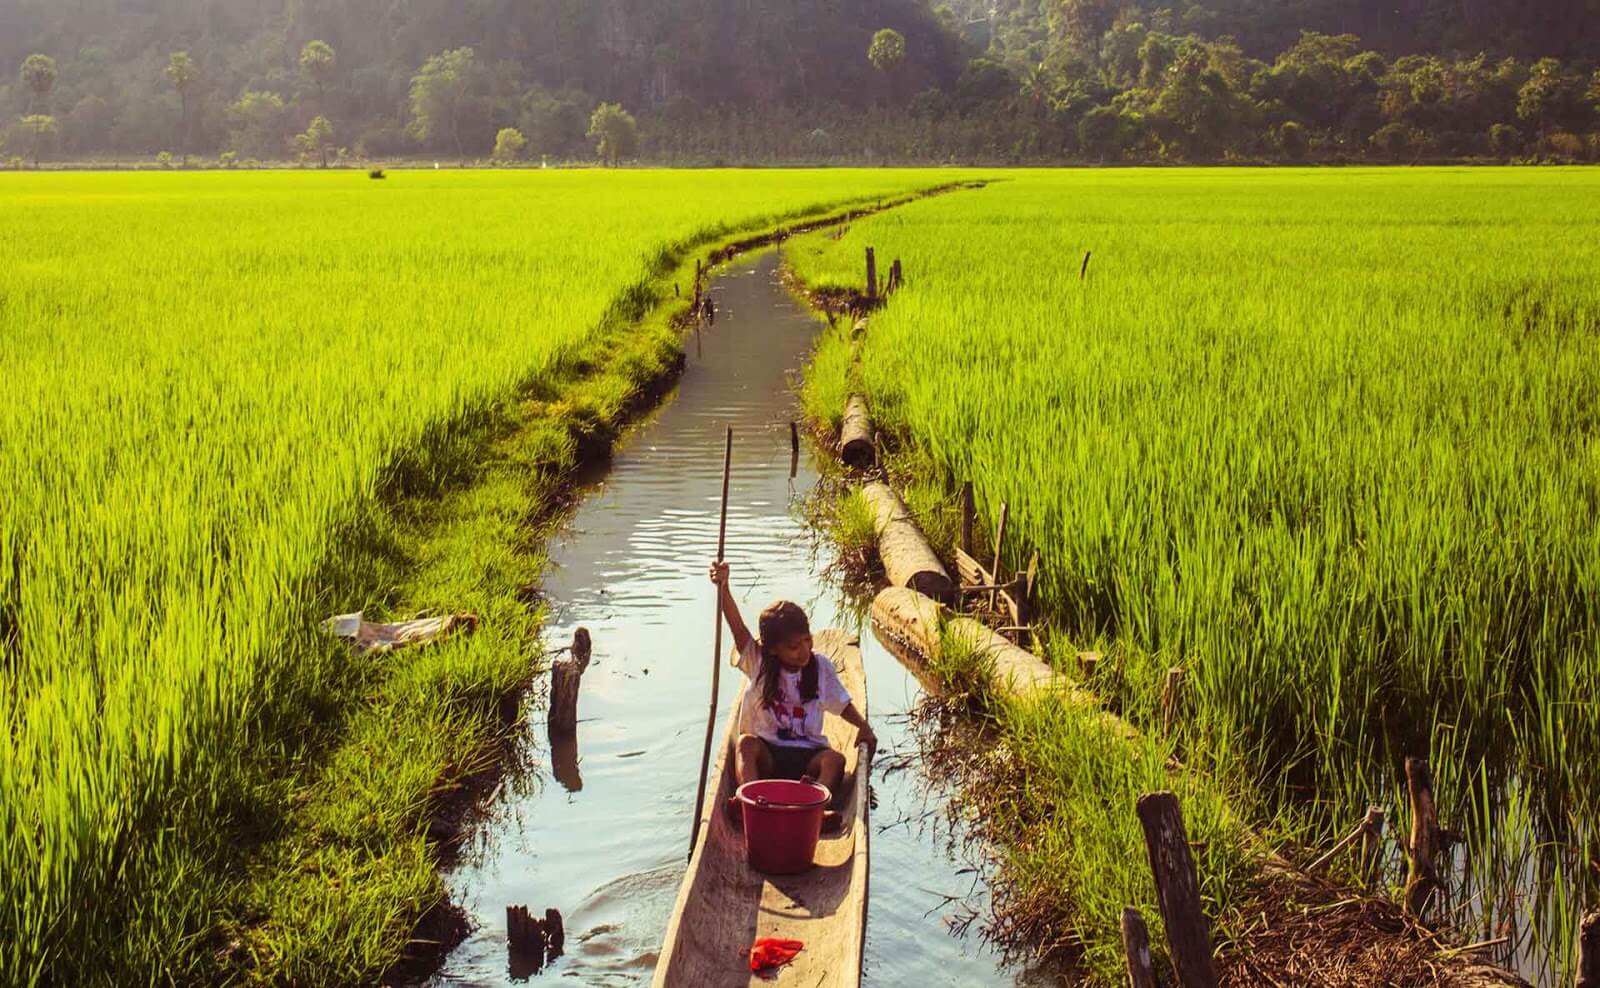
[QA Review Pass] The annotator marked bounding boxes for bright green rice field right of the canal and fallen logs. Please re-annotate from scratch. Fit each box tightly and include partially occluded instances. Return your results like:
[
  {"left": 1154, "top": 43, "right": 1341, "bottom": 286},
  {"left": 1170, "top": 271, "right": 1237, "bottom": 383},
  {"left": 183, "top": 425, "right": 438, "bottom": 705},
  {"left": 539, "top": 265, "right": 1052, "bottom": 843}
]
[{"left": 792, "top": 168, "right": 1600, "bottom": 983}]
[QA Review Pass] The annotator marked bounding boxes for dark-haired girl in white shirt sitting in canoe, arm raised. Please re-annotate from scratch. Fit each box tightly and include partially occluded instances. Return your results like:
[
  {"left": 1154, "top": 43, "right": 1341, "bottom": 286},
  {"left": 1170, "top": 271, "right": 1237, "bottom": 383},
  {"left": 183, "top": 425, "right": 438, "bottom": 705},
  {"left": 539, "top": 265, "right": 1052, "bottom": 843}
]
[{"left": 710, "top": 563, "right": 878, "bottom": 828}]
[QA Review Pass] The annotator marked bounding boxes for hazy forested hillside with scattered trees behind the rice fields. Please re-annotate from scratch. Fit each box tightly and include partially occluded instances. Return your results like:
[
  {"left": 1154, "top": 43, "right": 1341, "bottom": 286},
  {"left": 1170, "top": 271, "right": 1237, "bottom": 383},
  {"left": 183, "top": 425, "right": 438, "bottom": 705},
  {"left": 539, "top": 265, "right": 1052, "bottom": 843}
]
[{"left": 0, "top": 0, "right": 1600, "bottom": 163}]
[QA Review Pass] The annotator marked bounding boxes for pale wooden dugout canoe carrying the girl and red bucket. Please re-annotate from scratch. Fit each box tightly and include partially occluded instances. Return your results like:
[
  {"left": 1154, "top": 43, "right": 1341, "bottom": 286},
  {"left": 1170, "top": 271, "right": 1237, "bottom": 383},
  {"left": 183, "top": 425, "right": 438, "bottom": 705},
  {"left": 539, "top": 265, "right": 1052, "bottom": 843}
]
[{"left": 651, "top": 630, "right": 870, "bottom": 988}]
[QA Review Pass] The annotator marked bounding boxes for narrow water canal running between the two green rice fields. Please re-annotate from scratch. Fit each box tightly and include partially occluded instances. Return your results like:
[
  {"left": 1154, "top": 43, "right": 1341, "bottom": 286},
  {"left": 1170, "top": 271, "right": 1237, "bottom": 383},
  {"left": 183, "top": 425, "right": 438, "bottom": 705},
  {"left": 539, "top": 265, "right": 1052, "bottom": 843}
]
[{"left": 429, "top": 253, "right": 1042, "bottom": 988}]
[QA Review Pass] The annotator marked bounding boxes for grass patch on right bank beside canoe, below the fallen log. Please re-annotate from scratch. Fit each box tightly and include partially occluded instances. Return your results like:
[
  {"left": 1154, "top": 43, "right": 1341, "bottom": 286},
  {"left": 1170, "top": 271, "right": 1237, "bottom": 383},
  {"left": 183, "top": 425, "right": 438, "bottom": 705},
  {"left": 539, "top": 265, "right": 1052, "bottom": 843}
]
[{"left": 914, "top": 628, "right": 1256, "bottom": 983}]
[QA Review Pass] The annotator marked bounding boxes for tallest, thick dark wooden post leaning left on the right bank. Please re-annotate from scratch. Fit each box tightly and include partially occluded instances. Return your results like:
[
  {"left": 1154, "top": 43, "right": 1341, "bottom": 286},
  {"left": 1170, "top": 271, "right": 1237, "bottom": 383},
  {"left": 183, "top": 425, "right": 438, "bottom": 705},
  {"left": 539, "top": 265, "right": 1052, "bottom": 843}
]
[{"left": 1138, "top": 791, "right": 1216, "bottom": 988}]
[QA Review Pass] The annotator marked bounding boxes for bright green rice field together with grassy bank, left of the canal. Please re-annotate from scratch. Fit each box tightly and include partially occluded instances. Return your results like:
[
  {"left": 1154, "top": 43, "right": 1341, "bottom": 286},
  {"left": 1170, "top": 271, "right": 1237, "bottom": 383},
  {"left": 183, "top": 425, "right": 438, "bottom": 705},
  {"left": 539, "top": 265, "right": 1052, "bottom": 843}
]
[{"left": 0, "top": 171, "right": 947, "bottom": 985}]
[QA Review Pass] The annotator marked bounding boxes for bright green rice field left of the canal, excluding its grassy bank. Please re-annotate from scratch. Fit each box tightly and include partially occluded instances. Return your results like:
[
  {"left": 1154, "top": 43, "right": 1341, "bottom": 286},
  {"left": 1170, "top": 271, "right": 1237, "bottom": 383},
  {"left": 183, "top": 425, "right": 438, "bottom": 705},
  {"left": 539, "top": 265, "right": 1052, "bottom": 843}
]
[{"left": 0, "top": 169, "right": 942, "bottom": 985}]
